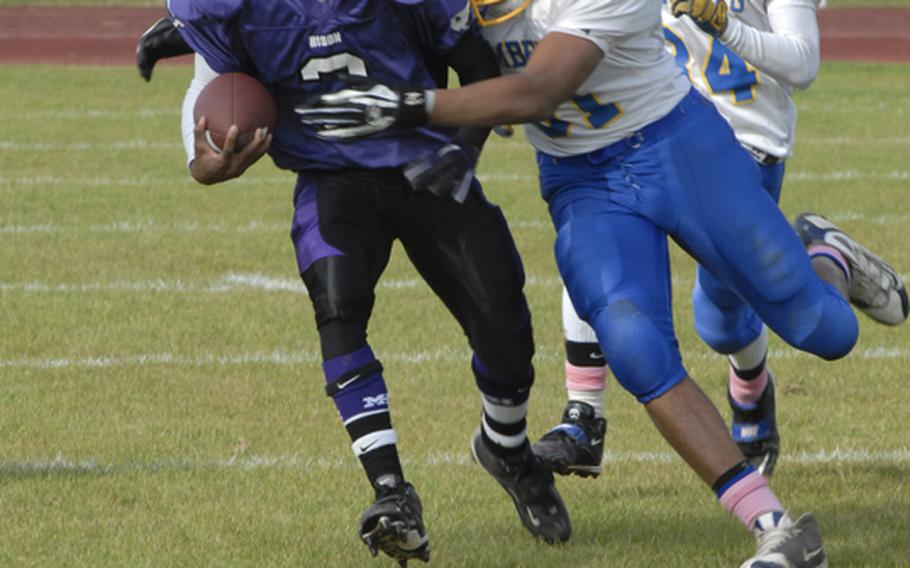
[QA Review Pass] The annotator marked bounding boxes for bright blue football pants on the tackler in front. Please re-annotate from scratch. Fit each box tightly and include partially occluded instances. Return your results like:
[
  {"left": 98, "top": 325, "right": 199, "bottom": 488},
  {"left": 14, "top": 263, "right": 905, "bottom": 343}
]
[{"left": 537, "top": 90, "right": 858, "bottom": 402}]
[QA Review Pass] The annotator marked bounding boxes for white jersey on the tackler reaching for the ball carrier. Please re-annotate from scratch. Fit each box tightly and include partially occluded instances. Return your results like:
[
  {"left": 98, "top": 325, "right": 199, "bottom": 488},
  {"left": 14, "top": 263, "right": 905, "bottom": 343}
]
[{"left": 483, "top": 0, "right": 692, "bottom": 156}]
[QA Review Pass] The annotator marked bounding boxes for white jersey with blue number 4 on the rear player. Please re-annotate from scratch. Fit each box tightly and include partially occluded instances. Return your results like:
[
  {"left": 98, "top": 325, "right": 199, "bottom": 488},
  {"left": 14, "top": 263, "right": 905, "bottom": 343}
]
[{"left": 662, "top": 0, "right": 814, "bottom": 158}]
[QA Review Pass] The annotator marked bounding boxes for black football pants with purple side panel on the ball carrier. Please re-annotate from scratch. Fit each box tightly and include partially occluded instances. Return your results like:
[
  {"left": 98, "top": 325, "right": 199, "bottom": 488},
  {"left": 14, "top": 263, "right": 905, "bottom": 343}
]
[{"left": 292, "top": 169, "right": 534, "bottom": 382}]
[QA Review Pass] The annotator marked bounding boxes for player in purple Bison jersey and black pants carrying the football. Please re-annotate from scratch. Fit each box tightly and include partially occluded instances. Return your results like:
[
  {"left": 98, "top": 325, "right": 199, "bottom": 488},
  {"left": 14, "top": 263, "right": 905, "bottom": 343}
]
[{"left": 157, "top": 0, "right": 571, "bottom": 565}]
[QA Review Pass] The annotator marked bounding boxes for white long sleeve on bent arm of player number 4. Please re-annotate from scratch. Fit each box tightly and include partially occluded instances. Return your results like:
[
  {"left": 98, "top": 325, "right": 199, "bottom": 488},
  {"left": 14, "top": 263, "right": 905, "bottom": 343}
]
[{"left": 721, "top": 0, "right": 819, "bottom": 89}]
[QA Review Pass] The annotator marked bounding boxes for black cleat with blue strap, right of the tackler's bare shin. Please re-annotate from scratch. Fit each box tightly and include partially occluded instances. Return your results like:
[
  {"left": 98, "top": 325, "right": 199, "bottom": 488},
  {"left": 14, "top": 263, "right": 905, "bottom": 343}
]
[{"left": 727, "top": 373, "right": 780, "bottom": 476}]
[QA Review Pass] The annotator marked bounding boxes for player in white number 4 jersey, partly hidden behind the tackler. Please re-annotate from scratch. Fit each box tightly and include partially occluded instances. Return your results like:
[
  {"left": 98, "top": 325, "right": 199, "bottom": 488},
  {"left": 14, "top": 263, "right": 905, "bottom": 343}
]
[{"left": 534, "top": 0, "right": 907, "bottom": 484}]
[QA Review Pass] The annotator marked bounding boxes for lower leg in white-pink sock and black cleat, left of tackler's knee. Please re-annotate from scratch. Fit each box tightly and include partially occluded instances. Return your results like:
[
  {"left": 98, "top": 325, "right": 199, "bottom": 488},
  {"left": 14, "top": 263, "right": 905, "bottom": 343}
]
[{"left": 532, "top": 288, "right": 607, "bottom": 477}]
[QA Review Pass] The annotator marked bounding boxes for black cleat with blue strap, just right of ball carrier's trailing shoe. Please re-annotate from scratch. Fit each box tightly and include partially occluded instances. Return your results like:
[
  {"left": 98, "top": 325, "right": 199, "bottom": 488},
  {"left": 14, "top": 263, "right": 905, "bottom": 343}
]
[{"left": 531, "top": 400, "right": 607, "bottom": 477}]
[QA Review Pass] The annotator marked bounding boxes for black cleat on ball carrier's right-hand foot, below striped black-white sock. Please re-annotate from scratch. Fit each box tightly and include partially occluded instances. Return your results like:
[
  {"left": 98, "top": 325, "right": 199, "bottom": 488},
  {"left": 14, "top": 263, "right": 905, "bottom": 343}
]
[{"left": 471, "top": 428, "right": 572, "bottom": 544}]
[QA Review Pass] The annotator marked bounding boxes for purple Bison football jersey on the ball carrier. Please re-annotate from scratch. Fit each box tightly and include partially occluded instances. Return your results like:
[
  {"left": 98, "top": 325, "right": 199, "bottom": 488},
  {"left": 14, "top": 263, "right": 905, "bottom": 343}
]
[{"left": 168, "top": 0, "right": 473, "bottom": 171}]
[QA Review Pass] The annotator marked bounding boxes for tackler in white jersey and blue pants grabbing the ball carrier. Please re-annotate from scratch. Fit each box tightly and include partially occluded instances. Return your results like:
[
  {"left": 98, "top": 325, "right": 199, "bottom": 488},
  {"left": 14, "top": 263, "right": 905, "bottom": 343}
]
[{"left": 297, "top": 0, "right": 906, "bottom": 567}]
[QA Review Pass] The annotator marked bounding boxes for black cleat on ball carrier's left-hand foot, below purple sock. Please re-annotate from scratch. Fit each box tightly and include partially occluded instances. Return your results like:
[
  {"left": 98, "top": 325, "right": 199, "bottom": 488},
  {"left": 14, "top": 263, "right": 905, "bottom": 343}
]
[{"left": 358, "top": 482, "right": 430, "bottom": 566}]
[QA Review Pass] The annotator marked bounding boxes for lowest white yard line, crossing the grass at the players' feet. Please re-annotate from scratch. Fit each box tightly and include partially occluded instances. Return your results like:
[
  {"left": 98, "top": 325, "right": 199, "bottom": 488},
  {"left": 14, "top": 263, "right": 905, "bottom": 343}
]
[{"left": 0, "top": 448, "right": 910, "bottom": 476}]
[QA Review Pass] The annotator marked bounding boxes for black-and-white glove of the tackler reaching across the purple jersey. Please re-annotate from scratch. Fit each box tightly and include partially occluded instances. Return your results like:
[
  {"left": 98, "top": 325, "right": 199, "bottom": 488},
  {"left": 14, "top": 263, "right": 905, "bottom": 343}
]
[{"left": 294, "top": 76, "right": 427, "bottom": 140}]
